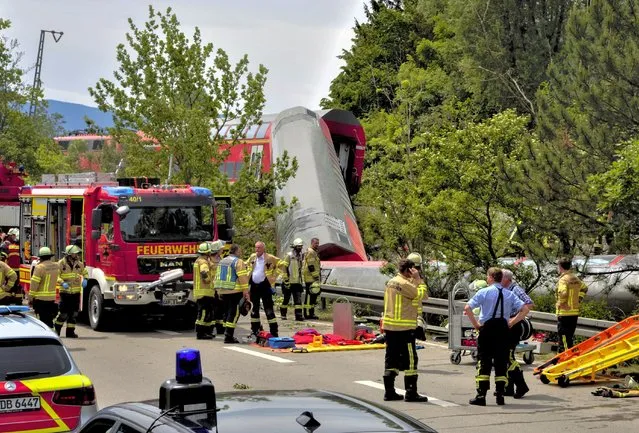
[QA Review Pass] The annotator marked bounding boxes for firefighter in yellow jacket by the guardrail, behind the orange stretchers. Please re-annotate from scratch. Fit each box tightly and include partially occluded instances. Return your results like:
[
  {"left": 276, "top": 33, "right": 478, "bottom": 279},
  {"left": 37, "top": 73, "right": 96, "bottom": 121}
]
[{"left": 556, "top": 258, "right": 588, "bottom": 353}]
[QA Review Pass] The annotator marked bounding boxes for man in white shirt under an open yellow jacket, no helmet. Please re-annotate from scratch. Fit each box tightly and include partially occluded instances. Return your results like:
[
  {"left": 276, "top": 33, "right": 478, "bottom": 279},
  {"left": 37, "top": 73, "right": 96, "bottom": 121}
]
[{"left": 247, "top": 241, "right": 280, "bottom": 337}]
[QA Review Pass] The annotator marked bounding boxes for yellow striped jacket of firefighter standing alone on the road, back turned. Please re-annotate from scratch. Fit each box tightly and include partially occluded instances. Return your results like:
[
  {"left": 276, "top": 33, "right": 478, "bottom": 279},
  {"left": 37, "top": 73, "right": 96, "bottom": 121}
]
[{"left": 383, "top": 275, "right": 428, "bottom": 331}]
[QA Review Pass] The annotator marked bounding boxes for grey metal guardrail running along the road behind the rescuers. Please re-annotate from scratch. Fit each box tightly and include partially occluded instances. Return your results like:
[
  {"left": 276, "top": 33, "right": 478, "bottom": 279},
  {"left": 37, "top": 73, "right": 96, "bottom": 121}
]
[{"left": 321, "top": 284, "right": 617, "bottom": 337}]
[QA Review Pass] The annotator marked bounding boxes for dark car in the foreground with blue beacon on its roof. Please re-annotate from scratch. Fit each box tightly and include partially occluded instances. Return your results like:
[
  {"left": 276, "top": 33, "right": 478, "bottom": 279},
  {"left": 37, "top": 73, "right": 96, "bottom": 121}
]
[{"left": 74, "top": 349, "right": 435, "bottom": 433}]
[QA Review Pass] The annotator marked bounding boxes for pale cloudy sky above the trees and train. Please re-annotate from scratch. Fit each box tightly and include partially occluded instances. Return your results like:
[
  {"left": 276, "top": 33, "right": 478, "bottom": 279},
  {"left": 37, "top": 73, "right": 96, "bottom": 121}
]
[{"left": 0, "top": 0, "right": 364, "bottom": 113}]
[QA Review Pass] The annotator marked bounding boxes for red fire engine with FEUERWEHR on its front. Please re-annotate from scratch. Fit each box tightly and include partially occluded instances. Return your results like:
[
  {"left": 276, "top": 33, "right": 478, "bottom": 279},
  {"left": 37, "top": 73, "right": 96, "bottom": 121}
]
[{"left": 19, "top": 173, "right": 233, "bottom": 330}]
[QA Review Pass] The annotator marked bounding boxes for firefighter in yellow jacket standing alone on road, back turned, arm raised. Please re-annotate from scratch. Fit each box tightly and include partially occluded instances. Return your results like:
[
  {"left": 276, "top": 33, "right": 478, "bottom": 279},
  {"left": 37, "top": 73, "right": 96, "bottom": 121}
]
[{"left": 382, "top": 259, "right": 428, "bottom": 402}]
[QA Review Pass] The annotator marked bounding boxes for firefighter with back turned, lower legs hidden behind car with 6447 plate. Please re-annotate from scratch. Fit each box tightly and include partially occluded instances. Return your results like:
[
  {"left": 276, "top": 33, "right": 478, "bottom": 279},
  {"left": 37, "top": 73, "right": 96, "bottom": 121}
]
[{"left": 29, "top": 247, "right": 60, "bottom": 330}]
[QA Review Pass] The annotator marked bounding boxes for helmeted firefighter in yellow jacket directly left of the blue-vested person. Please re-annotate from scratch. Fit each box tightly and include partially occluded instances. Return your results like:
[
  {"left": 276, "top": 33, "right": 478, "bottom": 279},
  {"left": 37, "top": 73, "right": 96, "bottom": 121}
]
[{"left": 193, "top": 242, "right": 215, "bottom": 340}]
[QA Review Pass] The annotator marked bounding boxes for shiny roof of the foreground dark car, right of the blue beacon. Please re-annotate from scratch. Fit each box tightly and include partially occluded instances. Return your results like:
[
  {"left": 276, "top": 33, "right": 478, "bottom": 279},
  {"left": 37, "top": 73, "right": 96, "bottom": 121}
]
[{"left": 145, "top": 390, "right": 435, "bottom": 433}]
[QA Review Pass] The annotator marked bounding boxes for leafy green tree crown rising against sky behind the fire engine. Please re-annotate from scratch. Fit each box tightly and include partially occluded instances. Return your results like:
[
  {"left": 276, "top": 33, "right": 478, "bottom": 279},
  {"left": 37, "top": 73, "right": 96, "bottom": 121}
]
[{"left": 89, "top": 6, "right": 267, "bottom": 184}]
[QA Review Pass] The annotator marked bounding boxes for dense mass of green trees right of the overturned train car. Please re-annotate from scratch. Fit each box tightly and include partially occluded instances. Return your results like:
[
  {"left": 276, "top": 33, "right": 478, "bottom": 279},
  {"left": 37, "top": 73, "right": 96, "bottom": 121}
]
[{"left": 323, "top": 0, "right": 639, "bottom": 290}]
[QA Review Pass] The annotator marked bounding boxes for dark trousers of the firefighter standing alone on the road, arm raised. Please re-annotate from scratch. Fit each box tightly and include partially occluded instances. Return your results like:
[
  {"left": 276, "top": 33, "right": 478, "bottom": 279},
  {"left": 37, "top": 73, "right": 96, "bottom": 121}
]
[{"left": 384, "top": 330, "right": 418, "bottom": 376}]
